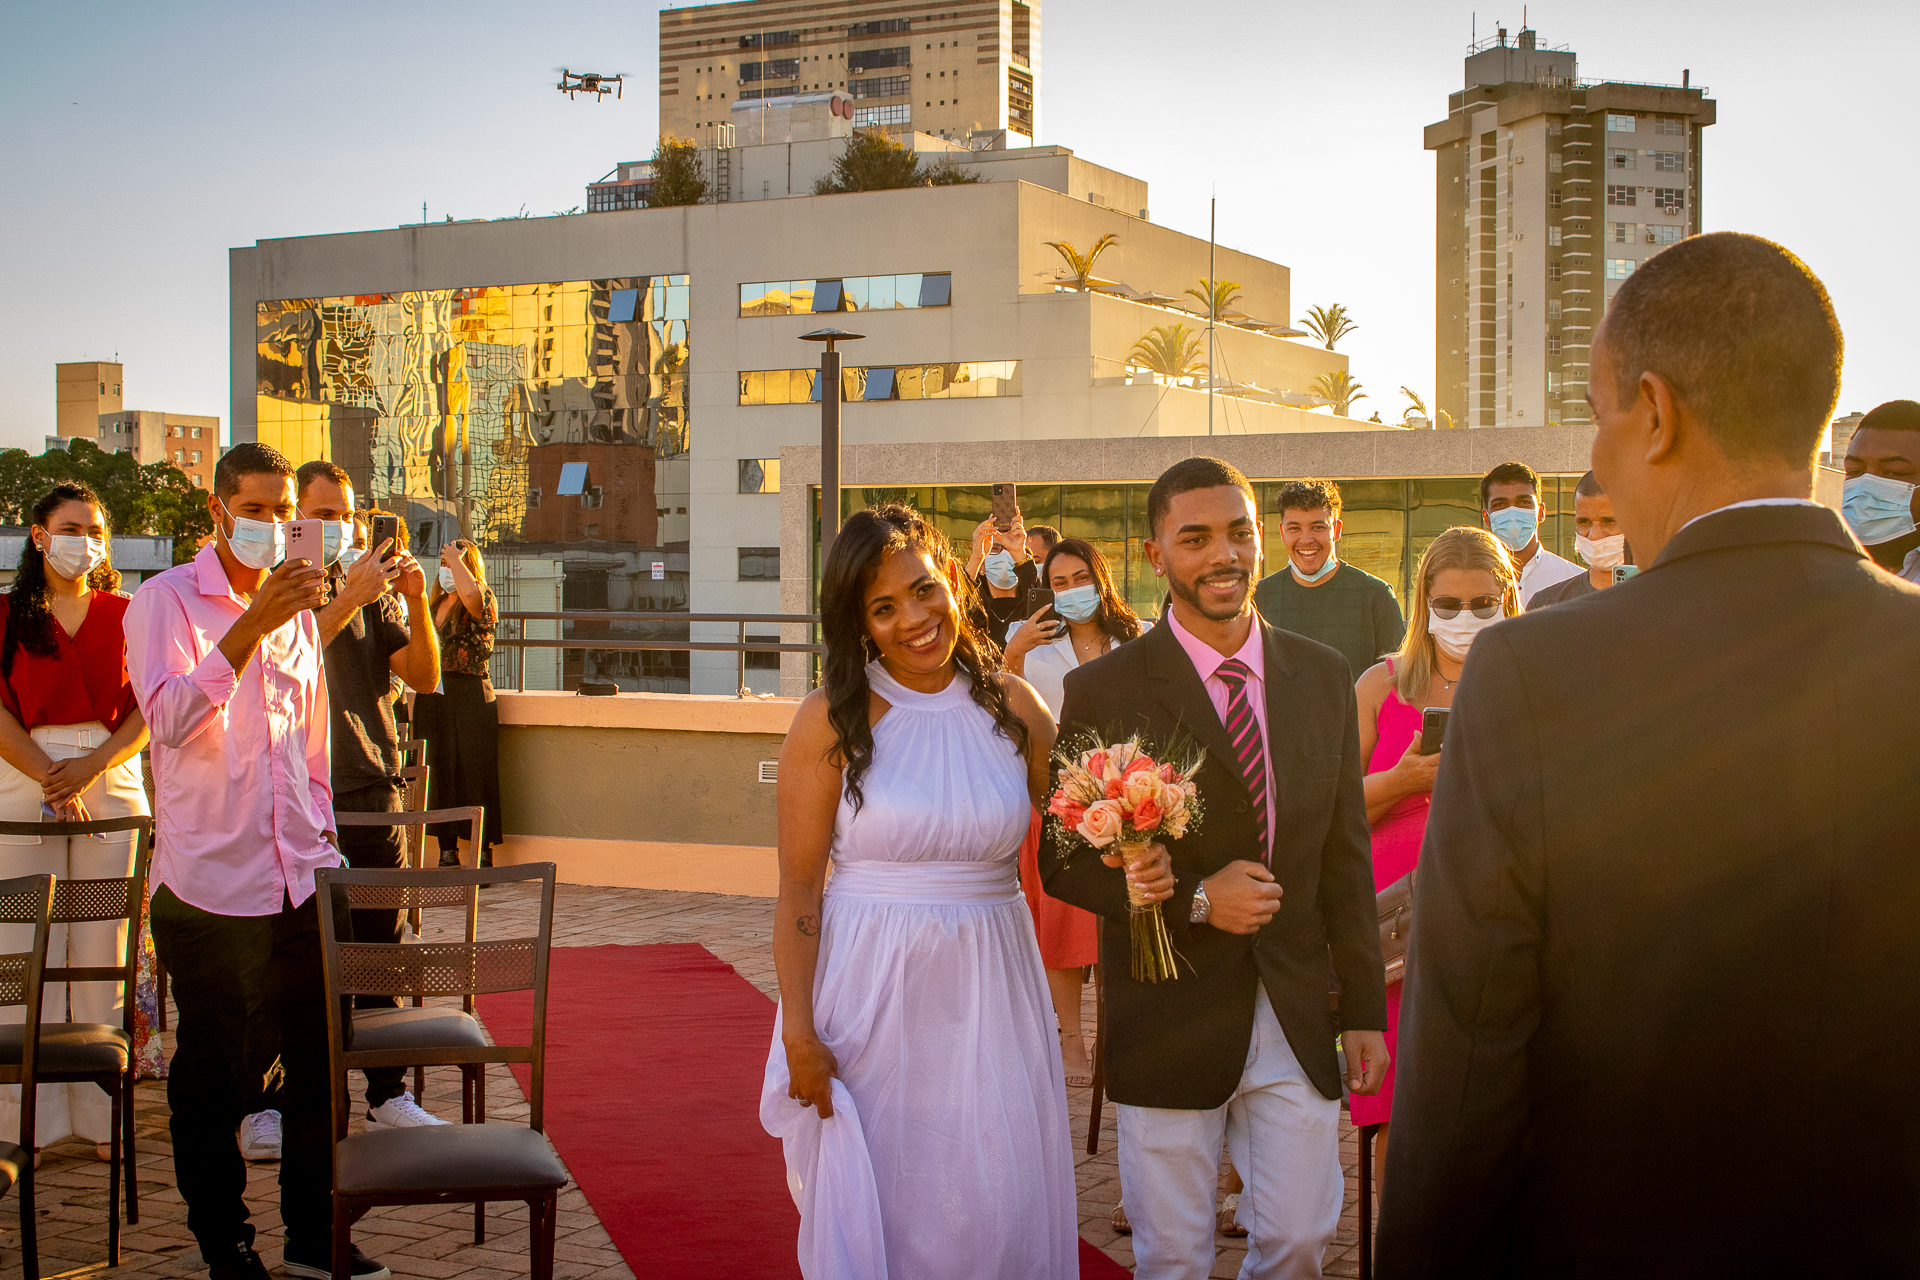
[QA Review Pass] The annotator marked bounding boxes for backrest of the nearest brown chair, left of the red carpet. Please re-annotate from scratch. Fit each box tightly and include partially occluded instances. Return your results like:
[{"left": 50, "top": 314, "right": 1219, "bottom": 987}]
[{"left": 315, "top": 867, "right": 555, "bottom": 1138}]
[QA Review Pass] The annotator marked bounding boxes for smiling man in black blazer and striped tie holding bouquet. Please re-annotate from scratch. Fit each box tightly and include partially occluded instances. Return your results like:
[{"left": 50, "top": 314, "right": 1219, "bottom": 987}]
[{"left": 1041, "top": 459, "right": 1386, "bottom": 1280}]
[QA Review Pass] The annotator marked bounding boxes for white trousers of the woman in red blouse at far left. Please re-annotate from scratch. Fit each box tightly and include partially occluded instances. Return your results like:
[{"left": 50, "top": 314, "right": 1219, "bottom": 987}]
[{"left": 0, "top": 720, "right": 148, "bottom": 1146}]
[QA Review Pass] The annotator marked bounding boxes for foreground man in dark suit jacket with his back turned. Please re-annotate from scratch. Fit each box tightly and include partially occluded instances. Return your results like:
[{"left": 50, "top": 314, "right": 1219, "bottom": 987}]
[{"left": 1379, "top": 232, "right": 1920, "bottom": 1280}]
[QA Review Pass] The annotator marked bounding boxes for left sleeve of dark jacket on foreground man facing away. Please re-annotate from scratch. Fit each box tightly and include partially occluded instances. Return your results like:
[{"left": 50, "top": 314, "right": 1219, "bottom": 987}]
[{"left": 1379, "top": 628, "right": 1546, "bottom": 1278}]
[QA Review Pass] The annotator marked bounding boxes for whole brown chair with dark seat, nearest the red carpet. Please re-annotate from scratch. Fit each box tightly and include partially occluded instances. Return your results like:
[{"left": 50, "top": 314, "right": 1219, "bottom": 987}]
[{"left": 315, "top": 862, "right": 566, "bottom": 1280}]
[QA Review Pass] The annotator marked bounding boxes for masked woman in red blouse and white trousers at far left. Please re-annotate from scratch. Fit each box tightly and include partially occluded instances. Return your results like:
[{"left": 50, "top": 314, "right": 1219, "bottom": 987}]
[{"left": 0, "top": 484, "right": 148, "bottom": 1159}]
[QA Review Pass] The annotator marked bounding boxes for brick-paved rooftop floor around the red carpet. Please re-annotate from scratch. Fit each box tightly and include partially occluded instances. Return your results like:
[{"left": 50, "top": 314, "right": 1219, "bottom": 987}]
[{"left": 0, "top": 885, "right": 1382, "bottom": 1280}]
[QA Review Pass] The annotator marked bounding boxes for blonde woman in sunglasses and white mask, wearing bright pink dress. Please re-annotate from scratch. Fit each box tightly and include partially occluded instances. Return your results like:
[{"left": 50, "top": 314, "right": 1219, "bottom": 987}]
[{"left": 1352, "top": 528, "right": 1521, "bottom": 1178}]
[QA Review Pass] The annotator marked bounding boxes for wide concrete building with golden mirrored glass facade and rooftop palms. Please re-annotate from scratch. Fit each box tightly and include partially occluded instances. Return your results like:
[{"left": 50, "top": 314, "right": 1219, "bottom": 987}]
[{"left": 230, "top": 166, "right": 1359, "bottom": 693}]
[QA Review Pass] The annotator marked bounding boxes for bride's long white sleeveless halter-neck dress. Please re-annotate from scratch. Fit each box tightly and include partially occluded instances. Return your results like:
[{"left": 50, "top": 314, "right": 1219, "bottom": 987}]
[{"left": 760, "top": 662, "right": 1079, "bottom": 1280}]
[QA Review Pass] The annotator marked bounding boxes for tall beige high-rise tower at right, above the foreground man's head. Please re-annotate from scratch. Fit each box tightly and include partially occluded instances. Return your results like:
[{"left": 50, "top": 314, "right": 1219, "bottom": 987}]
[{"left": 1427, "top": 29, "right": 1715, "bottom": 426}]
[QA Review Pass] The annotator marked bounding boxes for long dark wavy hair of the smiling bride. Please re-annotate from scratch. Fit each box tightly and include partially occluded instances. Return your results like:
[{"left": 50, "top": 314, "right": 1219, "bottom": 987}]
[{"left": 820, "top": 503, "right": 1027, "bottom": 812}]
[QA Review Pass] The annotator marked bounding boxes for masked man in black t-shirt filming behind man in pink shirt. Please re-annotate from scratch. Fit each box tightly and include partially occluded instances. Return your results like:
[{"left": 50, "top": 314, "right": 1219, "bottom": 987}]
[{"left": 296, "top": 462, "right": 445, "bottom": 1128}]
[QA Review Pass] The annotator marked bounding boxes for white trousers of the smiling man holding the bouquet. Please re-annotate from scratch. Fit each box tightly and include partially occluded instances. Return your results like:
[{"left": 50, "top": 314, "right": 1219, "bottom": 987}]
[{"left": 1117, "top": 984, "right": 1346, "bottom": 1280}]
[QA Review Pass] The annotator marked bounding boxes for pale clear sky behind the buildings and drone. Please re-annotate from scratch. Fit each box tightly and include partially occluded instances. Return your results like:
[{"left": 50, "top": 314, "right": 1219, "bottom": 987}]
[{"left": 0, "top": 0, "right": 1920, "bottom": 451}]
